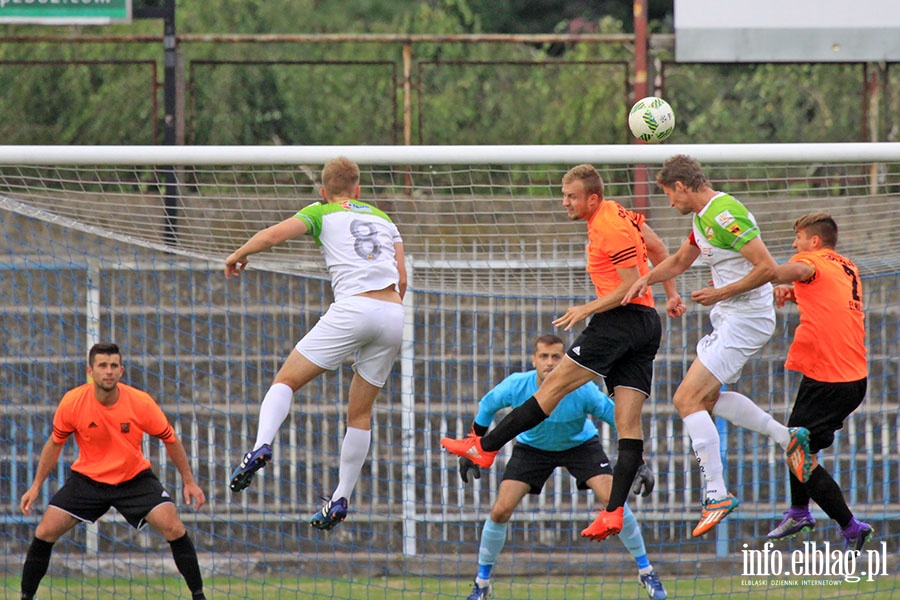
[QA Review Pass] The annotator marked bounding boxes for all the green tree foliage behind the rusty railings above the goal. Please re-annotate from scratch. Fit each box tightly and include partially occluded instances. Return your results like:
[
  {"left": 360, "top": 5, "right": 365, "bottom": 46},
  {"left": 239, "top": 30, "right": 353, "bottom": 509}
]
[{"left": 0, "top": 0, "right": 888, "bottom": 144}]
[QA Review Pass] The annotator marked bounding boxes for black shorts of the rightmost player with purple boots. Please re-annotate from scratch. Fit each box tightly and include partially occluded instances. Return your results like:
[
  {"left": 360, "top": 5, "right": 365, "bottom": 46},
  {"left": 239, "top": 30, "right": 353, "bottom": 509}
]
[{"left": 788, "top": 375, "right": 868, "bottom": 453}]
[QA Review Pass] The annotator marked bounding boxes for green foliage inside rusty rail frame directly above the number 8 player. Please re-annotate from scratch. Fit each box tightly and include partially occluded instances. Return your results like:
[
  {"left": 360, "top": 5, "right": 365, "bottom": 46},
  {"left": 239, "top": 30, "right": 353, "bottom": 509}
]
[{"left": 188, "top": 63, "right": 398, "bottom": 145}]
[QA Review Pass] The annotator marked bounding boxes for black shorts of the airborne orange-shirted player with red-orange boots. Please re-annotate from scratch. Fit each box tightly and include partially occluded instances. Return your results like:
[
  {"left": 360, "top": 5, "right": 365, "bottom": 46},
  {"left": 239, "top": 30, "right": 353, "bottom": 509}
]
[{"left": 566, "top": 304, "right": 662, "bottom": 396}]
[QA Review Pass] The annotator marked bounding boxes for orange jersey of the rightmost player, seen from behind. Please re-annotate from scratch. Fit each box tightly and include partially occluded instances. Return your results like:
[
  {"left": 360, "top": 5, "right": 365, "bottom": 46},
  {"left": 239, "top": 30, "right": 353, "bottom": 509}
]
[{"left": 784, "top": 248, "right": 868, "bottom": 383}]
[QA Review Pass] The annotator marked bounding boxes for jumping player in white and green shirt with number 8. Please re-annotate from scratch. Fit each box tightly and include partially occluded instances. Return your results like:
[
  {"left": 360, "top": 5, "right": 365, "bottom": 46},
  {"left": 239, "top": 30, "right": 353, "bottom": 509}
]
[{"left": 225, "top": 158, "right": 406, "bottom": 530}]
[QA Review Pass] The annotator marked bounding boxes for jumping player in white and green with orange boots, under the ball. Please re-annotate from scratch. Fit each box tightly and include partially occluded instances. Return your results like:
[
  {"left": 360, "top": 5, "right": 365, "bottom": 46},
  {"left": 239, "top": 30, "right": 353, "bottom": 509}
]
[{"left": 625, "top": 155, "right": 811, "bottom": 536}]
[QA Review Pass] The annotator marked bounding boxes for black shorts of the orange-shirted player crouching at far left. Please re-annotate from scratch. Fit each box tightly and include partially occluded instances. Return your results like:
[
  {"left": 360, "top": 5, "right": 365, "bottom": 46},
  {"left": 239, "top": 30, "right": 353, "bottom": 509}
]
[{"left": 49, "top": 469, "right": 172, "bottom": 529}]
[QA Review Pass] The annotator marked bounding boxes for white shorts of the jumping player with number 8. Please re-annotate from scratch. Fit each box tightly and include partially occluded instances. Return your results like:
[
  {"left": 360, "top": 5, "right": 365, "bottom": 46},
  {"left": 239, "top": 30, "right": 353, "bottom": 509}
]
[{"left": 296, "top": 296, "right": 404, "bottom": 387}]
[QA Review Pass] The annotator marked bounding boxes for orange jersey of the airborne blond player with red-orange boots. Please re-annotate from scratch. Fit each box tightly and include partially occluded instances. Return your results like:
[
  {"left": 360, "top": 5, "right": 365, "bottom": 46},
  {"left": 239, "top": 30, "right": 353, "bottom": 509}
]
[{"left": 587, "top": 200, "right": 655, "bottom": 307}]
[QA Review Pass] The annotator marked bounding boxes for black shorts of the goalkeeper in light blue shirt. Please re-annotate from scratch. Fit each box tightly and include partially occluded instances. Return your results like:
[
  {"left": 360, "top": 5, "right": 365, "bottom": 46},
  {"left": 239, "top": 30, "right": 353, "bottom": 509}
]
[{"left": 501, "top": 437, "right": 612, "bottom": 494}]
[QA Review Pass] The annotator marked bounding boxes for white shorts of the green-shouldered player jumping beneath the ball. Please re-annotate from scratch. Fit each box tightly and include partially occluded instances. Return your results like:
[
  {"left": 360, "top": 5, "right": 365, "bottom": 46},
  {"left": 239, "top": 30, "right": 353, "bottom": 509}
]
[{"left": 697, "top": 308, "right": 775, "bottom": 383}]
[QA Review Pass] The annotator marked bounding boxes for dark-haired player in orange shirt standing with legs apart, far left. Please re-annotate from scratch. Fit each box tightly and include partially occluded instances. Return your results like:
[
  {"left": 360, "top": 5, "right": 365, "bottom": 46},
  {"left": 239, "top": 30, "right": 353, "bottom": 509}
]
[{"left": 19, "top": 343, "right": 206, "bottom": 600}]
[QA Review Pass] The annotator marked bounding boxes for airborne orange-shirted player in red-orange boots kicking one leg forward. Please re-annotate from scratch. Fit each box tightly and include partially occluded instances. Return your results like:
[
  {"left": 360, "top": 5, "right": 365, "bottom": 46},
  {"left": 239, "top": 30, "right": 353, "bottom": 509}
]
[{"left": 441, "top": 164, "right": 685, "bottom": 539}]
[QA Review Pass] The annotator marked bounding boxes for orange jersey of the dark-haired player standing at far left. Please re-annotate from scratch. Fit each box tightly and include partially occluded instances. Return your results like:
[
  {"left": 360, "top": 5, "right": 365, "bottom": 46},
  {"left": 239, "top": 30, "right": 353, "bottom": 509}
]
[{"left": 53, "top": 382, "right": 175, "bottom": 484}]
